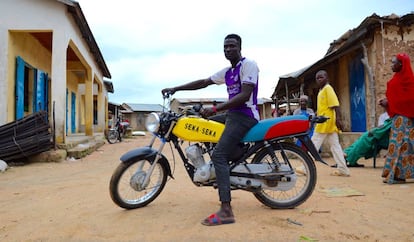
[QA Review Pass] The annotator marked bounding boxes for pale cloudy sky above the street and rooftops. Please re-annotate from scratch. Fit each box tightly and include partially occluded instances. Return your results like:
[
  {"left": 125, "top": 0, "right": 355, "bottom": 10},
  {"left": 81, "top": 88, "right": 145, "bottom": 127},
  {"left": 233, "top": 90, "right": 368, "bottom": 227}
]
[{"left": 78, "top": 0, "right": 414, "bottom": 104}]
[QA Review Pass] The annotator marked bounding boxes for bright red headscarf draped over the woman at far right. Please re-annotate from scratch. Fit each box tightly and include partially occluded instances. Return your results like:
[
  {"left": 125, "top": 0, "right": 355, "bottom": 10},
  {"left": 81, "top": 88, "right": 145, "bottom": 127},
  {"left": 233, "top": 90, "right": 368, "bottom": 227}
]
[{"left": 385, "top": 53, "right": 414, "bottom": 118}]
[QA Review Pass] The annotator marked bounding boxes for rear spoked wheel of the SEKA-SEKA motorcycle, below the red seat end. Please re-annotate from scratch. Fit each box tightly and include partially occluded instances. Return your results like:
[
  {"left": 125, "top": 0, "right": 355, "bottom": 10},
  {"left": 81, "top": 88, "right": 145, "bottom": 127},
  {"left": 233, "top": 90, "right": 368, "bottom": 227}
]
[{"left": 252, "top": 143, "right": 317, "bottom": 209}]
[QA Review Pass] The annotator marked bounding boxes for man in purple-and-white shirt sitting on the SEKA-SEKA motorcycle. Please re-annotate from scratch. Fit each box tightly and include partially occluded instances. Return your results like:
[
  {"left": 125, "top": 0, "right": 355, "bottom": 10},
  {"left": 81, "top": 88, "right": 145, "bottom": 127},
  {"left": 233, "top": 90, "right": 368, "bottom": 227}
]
[{"left": 162, "top": 34, "right": 260, "bottom": 226}]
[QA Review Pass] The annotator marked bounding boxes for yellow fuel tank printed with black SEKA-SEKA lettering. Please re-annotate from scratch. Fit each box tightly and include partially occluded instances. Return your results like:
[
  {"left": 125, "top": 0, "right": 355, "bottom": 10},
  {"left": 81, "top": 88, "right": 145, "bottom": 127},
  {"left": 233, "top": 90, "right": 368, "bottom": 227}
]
[{"left": 172, "top": 117, "right": 224, "bottom": 143}]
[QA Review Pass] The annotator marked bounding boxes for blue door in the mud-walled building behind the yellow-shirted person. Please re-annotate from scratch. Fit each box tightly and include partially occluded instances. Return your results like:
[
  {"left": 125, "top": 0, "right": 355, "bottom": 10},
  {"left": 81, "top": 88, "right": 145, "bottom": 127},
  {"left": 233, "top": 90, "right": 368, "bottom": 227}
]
[{"left": 349, "top": 54, "right": 367, "bottom": 132}]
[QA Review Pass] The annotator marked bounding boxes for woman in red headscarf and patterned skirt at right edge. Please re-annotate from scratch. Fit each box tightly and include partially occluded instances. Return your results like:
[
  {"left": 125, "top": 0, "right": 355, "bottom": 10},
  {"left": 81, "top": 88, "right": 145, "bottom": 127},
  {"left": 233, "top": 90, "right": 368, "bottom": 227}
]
[{"left": 379, "top": 53, "right": 414, "bottom": 184}]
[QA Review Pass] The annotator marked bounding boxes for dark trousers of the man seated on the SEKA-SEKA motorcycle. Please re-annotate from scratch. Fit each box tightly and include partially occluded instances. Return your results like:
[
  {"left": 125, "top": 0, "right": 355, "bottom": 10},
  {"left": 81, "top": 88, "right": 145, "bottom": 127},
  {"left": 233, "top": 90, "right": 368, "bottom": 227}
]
[{"left": 211, "top": 112, "right": 257, "bottom": 202}]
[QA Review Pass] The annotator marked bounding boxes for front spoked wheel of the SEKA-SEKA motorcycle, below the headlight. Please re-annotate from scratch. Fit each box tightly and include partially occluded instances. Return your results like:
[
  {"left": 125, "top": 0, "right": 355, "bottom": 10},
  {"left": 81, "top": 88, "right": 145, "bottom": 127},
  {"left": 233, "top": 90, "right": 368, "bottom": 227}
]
[{"left": 109, "top": 159, "right": 168, "bottom": 209}]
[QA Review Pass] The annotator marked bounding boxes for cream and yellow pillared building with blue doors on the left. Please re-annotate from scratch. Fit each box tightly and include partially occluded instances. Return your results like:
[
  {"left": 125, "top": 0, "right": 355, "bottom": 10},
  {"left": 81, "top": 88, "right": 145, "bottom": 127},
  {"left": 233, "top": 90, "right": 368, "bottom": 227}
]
[{"left": 0, "top": 0, "right": 113, "bottom": 144}]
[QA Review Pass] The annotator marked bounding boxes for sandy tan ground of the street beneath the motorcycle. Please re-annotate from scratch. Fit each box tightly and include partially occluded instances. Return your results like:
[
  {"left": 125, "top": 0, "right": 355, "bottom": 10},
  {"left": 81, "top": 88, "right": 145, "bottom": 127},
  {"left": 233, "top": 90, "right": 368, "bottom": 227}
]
[{"left": 0, "top": 137, "right": 414, "bottom": 241}]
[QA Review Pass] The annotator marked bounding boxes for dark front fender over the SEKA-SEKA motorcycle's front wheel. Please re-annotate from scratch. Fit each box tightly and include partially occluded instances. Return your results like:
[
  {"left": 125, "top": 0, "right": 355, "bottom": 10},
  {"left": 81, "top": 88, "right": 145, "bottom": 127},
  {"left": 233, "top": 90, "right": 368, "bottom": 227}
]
[{"left": 120, "top": 147, "right": 174, "bottom": 178}]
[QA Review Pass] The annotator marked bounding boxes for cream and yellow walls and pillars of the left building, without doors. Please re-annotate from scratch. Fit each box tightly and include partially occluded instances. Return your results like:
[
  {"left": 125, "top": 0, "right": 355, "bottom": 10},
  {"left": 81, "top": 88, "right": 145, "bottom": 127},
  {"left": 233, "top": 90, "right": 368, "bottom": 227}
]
[{"left": 0, "top": 0, "right": 107, "bottom": 142}]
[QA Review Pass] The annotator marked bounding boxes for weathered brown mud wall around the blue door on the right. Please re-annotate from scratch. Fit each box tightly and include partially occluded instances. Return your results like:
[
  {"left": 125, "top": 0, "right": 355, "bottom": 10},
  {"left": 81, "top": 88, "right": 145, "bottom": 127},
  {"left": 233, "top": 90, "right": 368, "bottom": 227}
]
[{"left": 322, "top": 25, "right": 414, "bottom": 156}]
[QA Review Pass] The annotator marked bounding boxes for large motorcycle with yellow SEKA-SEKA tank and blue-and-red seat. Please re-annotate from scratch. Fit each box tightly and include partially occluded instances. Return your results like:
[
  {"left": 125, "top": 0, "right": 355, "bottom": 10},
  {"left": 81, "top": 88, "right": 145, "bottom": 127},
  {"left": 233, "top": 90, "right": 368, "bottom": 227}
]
[{"left": 109, "top": 93, "right": 327, "bottom": 209}]
